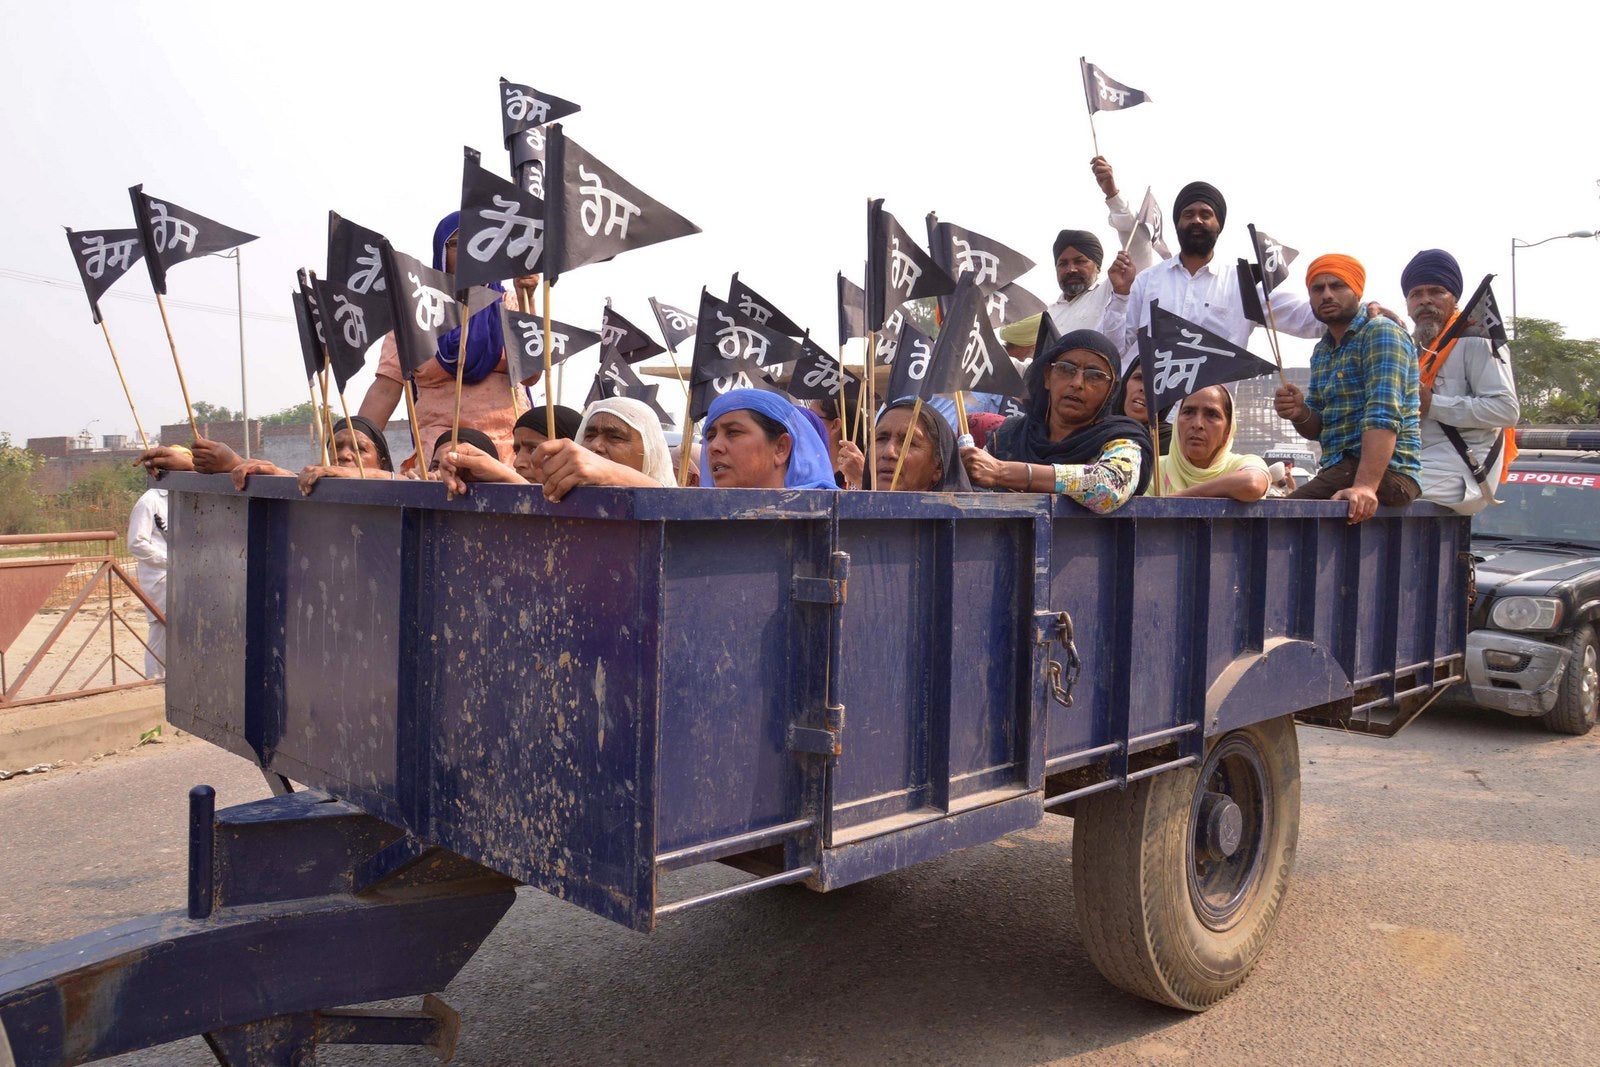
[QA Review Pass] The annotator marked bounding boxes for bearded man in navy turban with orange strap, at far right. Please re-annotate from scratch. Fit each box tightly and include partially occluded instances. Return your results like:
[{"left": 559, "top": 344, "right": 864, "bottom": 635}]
[{"left": 1400, "top": 248, "right": 1522, "bottom": 515}]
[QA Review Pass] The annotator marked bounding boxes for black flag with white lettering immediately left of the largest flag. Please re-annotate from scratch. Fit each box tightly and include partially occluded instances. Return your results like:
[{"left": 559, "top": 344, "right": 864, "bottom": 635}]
[{"left": 456, "top": 149, "right": 544, "bottom": 290}]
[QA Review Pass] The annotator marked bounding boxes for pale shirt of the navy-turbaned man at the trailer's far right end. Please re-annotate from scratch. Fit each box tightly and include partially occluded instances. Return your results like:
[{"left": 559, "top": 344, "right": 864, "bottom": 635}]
[{"left": 1418, "top": 338, "right": 1522, "bottom": 515}]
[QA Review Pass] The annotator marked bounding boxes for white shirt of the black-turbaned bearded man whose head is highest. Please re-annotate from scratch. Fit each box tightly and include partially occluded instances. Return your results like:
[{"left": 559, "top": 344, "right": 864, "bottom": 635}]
[{"left": 1099, "top": 256, "right": 1326, "bottom": 368}]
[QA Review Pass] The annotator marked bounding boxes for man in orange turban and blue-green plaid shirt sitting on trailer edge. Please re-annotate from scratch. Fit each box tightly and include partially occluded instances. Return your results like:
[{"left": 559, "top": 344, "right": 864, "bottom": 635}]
[{"left": 1274, "top": 254, "right": 1422, "bottom": 523}]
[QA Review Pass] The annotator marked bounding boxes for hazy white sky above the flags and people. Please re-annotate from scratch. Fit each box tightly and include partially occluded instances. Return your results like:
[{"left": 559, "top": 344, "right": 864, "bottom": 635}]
[{"left": 0, "top": 0, "right": 1600, "bottom": 442}]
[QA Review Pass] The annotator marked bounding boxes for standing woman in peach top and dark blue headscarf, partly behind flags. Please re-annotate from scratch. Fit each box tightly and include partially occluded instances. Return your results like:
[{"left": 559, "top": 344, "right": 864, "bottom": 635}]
[{"left": 360, "top": 211, "right": 526, "bottom": 467}]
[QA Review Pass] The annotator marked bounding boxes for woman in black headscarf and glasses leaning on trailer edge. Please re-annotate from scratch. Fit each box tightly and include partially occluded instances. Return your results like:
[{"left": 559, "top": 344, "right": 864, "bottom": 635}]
[{"left": 962, "top": 330, "right": 1155, "bottom": 514}]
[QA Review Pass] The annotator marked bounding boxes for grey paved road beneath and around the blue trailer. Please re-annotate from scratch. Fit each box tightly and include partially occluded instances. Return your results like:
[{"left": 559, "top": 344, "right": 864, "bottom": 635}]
[{"left": 0, "top": 713, "right": 1600, "bottom": 1067}]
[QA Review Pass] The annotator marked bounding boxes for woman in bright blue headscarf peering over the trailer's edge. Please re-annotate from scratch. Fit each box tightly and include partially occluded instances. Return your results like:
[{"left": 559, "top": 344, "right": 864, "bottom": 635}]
[{"left": 701, "top": 389, "right": 838, "bottom": 490}]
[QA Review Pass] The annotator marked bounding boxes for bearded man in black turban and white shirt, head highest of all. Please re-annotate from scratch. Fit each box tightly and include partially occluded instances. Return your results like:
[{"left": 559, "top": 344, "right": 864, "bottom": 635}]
[{"left": 1099, "top": 181, "right": 1322, "bottom": 365}]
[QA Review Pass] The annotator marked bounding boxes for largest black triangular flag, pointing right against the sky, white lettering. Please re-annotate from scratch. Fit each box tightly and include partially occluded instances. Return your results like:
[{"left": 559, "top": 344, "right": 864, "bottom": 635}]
[{"left": 544, "top": 123, "right": 701, "bottom": 283}]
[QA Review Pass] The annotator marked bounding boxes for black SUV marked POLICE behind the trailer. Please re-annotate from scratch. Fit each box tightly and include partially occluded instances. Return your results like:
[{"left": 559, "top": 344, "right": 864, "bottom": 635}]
[{"left": 1451, "top": 429, "right": 1600, "bottom": 734}]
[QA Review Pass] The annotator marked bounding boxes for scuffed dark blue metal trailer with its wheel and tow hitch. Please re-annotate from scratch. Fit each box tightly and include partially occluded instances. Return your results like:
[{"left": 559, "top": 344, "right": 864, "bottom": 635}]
[{"left": 0, "top": 475, "right": 1472, "bottom": 1064}]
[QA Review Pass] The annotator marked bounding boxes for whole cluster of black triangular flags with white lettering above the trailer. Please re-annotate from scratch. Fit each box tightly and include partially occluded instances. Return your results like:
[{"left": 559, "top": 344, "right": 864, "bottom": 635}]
[{"left": 67, "top": 59, "right": 1504, "bottom": 483}]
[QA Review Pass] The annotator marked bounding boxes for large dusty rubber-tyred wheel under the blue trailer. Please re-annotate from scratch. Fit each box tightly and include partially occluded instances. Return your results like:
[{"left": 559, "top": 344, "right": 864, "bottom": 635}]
[{"left": 1072, "top": 715, "right": 1299, "bottom": 1011}]
